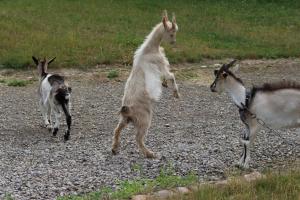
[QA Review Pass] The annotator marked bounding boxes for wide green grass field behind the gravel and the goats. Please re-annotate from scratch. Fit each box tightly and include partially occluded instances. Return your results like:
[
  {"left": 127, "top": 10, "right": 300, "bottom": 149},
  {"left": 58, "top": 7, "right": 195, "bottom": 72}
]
[{"left": 0, "top": 0, "right": 300, "bottom": 68}]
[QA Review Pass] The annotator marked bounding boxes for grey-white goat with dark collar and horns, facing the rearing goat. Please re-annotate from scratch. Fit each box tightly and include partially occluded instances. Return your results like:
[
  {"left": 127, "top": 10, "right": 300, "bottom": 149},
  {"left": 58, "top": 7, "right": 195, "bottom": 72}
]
[{"left": 210, "top": 60, "right": 300, "bottom": 168}]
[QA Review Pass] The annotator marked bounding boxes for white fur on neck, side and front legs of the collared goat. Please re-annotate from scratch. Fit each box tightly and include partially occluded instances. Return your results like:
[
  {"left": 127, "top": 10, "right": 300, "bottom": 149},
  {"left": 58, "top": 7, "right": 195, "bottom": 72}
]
[{"left": 214, "top": 71, "right": 300, "bottom": 168}]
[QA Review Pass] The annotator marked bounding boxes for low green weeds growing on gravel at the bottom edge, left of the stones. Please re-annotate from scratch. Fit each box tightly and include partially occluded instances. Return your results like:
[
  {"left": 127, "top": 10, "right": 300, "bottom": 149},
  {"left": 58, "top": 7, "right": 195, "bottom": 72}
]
[{"left": 58, "top": 166, "right": 198, "bottom": 200}]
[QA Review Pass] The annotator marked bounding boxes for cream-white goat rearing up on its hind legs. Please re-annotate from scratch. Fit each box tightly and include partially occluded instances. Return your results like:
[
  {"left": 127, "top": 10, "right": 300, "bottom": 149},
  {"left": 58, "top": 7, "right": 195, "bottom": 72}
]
[{"left": 112, "top": 11, "right": 179, "bottom": 158}]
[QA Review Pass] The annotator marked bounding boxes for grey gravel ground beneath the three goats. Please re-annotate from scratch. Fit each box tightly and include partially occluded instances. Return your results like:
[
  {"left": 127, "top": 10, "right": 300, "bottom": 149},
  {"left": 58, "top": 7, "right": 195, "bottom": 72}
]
[{"left": 0, "top": 60, "right": 300, "bottom": 199}]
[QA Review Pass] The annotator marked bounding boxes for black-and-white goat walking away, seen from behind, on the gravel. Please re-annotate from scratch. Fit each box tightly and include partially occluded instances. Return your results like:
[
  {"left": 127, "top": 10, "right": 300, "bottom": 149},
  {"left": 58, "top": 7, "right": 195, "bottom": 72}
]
[{"left": 32, "top": 56, "right": 72, "bottom": 141}]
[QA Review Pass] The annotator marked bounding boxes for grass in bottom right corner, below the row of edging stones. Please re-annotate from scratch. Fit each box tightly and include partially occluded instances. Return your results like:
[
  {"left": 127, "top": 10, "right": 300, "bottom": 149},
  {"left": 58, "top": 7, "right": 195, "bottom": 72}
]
[{"left": 172, "top": 170, "right": 300, "bottom": 200}]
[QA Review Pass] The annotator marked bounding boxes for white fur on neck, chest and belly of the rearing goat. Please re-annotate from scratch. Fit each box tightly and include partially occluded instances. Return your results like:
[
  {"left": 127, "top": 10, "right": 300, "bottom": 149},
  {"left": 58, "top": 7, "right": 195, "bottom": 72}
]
[{"left": 123, "top": 22, "right": 178, "bottom": 105}]
